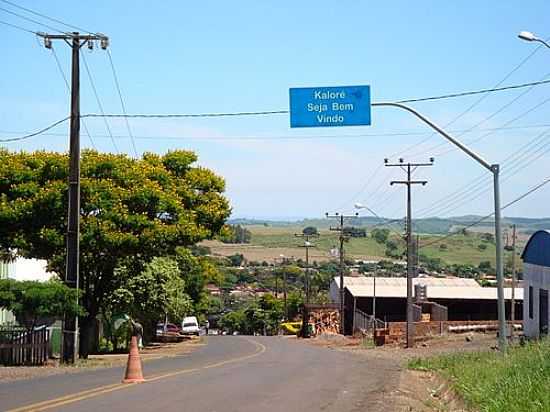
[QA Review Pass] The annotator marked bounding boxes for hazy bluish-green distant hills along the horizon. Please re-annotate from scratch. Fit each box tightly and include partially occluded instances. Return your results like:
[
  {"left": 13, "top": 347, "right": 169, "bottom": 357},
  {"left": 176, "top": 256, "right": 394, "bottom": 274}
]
[{"left": 228, "top": 215, "right": 550, "bottom": 234}]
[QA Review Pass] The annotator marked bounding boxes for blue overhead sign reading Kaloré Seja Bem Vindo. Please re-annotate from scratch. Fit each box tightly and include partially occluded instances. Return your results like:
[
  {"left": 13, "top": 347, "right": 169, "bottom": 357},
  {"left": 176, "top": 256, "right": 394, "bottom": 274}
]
[{"left": 289, "top": 86, "right": 370, "bottom": 127}]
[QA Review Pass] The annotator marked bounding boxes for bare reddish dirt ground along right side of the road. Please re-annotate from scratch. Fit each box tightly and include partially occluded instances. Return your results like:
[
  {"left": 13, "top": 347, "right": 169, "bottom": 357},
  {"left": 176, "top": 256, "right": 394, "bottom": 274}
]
[{"left": 307, "top": 333, "right": 496, "bottom": 412}]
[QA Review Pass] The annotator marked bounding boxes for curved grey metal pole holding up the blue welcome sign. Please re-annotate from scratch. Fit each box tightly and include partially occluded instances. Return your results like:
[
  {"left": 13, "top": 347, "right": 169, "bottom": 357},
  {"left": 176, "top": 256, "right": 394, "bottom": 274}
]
[{"left": 371, "top": 101, "right": 508, "bottom": 351}]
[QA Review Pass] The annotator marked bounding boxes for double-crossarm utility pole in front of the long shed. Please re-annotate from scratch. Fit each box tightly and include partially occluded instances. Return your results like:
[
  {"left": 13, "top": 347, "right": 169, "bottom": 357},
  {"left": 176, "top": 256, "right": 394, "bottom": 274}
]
[{"left": 384, "top": 158, "right": 433, "bottom": 348}]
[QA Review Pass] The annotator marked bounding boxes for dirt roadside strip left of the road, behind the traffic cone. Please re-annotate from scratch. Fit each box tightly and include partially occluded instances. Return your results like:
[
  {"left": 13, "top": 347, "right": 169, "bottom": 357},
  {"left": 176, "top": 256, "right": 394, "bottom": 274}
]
[{"left": 0, "top": 338, "right": 203, "bottom": 383}]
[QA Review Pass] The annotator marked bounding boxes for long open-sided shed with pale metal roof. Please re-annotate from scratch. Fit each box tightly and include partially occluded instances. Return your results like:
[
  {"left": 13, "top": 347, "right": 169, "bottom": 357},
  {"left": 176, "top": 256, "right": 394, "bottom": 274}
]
[{"left": 330, "top": 276, "right": 528, "bottom": 334}]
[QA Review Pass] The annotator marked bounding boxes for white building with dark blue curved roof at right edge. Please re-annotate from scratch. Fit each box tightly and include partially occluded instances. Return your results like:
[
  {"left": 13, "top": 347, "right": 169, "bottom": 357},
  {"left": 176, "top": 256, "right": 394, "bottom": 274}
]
[{"left": 521, "top": 230, "right": 550, "bottom": 338}]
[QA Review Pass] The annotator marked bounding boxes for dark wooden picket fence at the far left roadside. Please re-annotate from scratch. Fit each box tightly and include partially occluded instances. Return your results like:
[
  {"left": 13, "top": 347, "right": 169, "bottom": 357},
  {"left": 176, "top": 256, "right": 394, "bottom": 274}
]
[{"left": 0, "top": 327, "right": 50, "bottom": 366}]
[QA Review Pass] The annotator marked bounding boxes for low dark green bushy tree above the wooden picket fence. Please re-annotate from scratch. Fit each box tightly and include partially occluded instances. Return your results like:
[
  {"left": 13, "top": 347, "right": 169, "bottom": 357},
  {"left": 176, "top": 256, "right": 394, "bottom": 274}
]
[{"left": 0, "top": 279, "right": 83, "bottom": 329}]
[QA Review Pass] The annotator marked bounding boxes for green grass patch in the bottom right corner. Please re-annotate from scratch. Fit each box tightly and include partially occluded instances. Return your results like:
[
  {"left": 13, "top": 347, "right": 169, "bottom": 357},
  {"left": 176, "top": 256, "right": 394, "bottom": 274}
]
[{"left": 408, "top": 339, "right": 550, "bottom": 412}]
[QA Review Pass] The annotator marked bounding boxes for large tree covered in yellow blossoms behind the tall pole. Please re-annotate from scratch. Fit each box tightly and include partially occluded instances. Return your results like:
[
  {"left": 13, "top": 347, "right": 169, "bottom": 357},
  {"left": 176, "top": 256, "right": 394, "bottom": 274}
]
[{"left": 0, "top": 150, "right": 230, "bottom": 357}]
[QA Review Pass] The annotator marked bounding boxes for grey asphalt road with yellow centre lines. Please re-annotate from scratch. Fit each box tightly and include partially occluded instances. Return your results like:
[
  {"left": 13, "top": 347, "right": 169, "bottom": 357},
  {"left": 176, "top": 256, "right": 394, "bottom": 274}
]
[{"left": 0, "top": 336, "right": 399, "bottom": 412}]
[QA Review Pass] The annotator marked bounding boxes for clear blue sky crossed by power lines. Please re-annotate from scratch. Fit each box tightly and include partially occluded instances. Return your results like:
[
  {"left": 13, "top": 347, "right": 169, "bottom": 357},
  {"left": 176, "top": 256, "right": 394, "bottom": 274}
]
[{"left": 0, "top": 0, "right": 550, "bottom": 219}]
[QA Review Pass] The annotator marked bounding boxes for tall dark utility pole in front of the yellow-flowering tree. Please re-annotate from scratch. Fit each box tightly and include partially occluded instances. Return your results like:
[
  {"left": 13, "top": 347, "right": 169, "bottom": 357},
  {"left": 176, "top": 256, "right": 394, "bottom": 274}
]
[{"left": 37, "top": 32, "right": 109, "bottom": 363}]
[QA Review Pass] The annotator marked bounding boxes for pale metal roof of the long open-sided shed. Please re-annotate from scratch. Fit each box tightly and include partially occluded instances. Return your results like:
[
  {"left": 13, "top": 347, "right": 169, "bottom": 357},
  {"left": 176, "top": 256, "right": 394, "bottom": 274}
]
[{"left": 334, "top": 277, "right": 523, "bottom": 300}]
